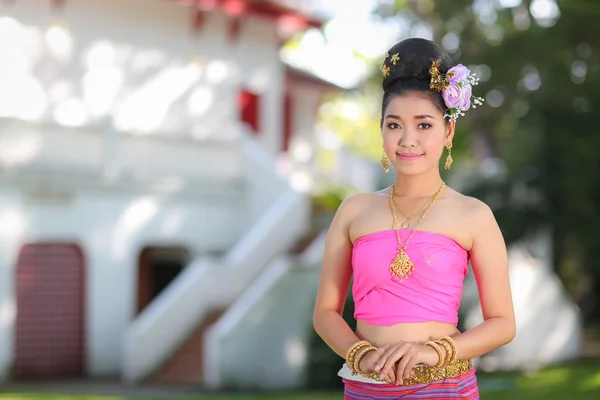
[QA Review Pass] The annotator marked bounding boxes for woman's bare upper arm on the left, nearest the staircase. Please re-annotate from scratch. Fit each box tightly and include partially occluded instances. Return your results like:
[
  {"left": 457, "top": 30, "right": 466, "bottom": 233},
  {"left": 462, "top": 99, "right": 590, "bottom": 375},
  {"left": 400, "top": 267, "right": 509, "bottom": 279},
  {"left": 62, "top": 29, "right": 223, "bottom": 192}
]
[{"left": 315, "top": 196, "right": 357, "bottom": 314}]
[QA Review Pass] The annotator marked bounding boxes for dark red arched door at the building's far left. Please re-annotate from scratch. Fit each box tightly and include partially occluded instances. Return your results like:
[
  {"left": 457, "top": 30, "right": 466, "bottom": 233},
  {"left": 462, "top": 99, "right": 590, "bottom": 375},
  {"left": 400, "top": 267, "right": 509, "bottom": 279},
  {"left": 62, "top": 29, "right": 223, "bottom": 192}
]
[{"left": 13, "top": 243, "right": 85, "bottom": 379}]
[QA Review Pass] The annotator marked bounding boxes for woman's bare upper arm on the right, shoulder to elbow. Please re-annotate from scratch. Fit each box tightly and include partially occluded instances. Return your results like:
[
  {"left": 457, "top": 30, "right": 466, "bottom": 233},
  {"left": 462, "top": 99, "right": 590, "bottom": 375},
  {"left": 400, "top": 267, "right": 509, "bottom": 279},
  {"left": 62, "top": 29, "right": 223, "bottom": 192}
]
[{"left": 470, "top": 200, "right": 514, "bottom": 321}]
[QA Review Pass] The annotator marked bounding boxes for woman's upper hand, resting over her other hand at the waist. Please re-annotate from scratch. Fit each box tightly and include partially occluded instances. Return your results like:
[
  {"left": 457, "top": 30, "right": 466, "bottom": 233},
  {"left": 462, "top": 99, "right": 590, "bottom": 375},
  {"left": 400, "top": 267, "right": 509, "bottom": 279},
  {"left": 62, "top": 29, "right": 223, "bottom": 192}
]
[{"left": 373, "top": 342, "right": 439, "bottom": 385}]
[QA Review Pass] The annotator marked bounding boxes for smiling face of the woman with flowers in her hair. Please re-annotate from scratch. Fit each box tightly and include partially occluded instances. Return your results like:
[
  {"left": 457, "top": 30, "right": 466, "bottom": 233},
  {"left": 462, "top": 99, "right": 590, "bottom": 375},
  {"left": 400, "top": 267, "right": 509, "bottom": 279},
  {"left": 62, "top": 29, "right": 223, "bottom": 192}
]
[{"left": 381, "top": 92, "right": 454, "bottom": 175}]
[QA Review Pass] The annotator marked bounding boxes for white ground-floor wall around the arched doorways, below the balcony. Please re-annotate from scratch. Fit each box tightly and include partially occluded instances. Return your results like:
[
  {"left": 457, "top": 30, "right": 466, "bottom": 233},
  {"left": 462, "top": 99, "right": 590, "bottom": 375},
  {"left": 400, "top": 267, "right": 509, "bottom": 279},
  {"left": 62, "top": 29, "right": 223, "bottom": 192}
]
[{"left": 0, "top": 181, "right": 242, "bottom": 376}]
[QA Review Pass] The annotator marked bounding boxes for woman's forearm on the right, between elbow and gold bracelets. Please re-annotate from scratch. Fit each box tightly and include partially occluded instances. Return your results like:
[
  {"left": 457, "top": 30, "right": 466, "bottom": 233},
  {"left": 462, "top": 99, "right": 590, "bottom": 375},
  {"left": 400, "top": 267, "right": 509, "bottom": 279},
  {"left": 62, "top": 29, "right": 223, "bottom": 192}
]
[{"left": 452, "top": 317, "right": 515, "bottom": 359}]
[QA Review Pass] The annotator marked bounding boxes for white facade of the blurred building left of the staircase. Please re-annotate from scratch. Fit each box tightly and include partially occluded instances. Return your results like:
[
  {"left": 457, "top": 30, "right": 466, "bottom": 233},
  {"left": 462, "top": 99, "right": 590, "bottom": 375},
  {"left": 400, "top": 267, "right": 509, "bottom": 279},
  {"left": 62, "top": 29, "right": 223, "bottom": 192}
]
[{"left": 0, "top": 0, "right": 304, "bottom": 379}]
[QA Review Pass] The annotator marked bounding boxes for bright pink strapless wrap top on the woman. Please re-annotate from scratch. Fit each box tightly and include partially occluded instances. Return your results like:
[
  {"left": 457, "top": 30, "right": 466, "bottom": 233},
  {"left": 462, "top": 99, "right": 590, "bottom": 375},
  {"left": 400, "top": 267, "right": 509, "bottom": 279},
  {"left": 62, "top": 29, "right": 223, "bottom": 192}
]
[{"left": 352, "top": 230, "right": 469, "bottom": 326}]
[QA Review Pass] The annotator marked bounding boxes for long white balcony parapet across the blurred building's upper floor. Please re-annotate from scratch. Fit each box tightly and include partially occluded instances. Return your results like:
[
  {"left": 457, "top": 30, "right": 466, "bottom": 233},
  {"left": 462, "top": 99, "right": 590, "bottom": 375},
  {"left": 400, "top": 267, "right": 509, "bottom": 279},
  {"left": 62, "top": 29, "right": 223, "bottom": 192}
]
[{"left": 0, "top": 118, "right": 245, "bottom": 196}]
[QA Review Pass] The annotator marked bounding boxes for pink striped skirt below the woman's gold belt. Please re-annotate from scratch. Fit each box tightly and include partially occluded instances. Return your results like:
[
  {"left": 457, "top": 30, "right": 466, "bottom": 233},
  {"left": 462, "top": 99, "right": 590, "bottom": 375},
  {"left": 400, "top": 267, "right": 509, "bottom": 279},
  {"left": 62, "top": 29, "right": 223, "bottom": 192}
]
[{"left": 343, "top": 368, "right": 479, "bottom": 400}]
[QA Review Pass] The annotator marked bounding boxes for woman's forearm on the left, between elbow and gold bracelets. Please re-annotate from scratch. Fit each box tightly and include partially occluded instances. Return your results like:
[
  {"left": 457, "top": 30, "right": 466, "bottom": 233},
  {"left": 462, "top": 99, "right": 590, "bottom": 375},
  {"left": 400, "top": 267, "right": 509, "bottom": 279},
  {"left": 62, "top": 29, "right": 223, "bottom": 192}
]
[{"left": 313, "top": 310, "right": 360, "bottom": 358}]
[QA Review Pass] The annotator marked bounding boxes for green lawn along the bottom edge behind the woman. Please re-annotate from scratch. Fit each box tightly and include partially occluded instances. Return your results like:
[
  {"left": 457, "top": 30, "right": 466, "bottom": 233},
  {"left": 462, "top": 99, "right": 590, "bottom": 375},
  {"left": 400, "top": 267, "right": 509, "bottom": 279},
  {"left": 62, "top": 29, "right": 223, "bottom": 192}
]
[{"left": 0, "top": 362, "right": 600, "bottom": 400}]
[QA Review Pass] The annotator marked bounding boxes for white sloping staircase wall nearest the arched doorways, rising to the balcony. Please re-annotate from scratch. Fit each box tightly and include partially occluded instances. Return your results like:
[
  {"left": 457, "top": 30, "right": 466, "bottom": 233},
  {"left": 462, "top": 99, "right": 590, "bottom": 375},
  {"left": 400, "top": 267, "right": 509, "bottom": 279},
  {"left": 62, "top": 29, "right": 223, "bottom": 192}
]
[{"left": 122, "top": 134, "right": 310, "bottom": 383}]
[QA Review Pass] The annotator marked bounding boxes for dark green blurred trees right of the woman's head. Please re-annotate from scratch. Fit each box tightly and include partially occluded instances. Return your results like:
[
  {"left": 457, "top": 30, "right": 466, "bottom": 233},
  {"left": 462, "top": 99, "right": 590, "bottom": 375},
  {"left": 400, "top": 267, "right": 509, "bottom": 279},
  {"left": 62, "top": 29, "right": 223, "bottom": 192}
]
[{"left": 376, "top": 0, "right": 600, "bottom": 322}]
